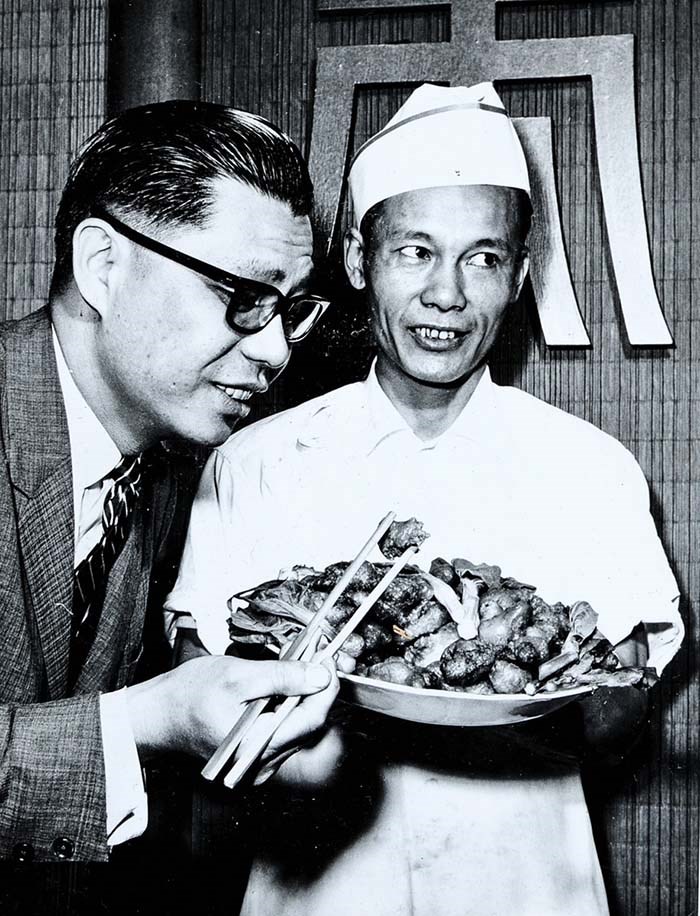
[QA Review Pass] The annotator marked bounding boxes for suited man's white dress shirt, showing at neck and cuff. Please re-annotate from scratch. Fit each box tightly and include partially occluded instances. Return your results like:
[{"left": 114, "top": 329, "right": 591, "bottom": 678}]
[{"left": 53, "top": 331, "right": 148, "bottom": 846}]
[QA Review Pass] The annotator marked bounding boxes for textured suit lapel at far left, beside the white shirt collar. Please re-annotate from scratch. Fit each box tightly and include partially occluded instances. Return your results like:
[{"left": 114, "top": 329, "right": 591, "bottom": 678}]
[{"left": 6, "top": 309, "right": 74, "bottom": 698}]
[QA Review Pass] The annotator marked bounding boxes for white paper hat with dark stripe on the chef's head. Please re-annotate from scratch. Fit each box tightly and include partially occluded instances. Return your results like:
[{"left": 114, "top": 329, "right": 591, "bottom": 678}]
[{"left": 348, "top": 83, "right": 530, "bottom": 226}]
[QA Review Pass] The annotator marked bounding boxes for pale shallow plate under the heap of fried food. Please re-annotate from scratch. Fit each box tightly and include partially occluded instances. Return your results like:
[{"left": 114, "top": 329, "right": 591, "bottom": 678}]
[{"left": 340, "top": 673, "right": 592, "bottom": 726}]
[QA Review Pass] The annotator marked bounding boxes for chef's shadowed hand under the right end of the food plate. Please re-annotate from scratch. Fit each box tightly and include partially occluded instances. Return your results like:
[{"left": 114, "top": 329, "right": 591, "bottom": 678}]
[{"left": 579, "top": 627, "right": 649, "bottom": 766}]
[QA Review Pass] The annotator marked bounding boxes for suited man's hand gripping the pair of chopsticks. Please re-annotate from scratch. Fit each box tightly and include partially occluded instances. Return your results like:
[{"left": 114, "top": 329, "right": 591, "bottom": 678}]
[{"left": 127, "top": 655, "right": 338, "bottom": 764}]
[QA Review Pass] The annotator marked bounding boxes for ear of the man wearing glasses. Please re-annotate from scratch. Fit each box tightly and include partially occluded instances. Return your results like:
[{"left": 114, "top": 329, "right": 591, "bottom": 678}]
[{"left": 73, "top": 217, "right": 125, "bottom": 316}]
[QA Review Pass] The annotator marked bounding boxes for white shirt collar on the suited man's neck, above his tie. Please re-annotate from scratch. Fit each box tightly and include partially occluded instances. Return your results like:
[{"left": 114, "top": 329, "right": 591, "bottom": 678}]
[{"left": 51, "top": 326, "right": 122, "bottom": 490}]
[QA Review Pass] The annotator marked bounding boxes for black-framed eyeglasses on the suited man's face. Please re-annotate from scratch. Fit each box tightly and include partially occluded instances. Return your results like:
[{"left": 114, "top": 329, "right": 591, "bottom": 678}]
[{"left": 92, "top": 207, "right": 330, "bottom": 343}]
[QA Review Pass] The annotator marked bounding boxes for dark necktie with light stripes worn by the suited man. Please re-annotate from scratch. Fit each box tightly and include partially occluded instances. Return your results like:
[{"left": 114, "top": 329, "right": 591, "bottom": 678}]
[{"left": 68, "top": 454, "right": 145, "bottom": 688}]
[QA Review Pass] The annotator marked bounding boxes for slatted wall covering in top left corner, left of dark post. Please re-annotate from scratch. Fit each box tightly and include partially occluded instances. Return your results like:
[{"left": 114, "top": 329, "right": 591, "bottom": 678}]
[{"left": 0, "top": 0, "right": 106, "bottom": 318}]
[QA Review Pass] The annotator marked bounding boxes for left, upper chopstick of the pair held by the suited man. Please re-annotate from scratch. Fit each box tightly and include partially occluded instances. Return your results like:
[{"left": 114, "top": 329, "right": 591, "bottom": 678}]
[{"left": 202, "top": 512, "right": 396, "bottom": 780}]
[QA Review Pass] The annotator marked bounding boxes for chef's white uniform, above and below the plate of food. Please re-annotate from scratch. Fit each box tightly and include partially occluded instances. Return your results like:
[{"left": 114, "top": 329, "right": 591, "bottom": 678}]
[{"left": 167, "top": 371, "right": 683, "bottom": 916}]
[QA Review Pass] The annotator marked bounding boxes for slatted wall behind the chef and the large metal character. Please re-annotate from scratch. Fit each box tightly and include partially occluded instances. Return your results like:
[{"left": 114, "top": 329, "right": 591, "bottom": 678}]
[{"left": 203, "top": 0, "right": 700, "bottom": 916}]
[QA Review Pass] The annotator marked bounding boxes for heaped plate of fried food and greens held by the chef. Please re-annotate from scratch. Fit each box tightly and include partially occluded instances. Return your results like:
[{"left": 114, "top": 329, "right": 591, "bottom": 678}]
[{"left": 229, "top": 519, "right": 654, "bottom": 726}]
